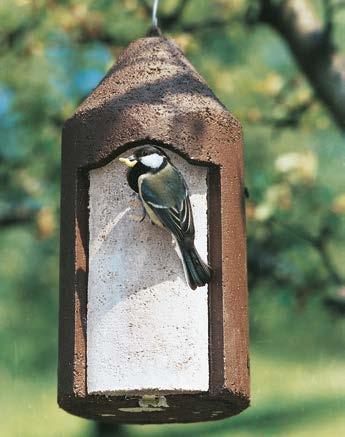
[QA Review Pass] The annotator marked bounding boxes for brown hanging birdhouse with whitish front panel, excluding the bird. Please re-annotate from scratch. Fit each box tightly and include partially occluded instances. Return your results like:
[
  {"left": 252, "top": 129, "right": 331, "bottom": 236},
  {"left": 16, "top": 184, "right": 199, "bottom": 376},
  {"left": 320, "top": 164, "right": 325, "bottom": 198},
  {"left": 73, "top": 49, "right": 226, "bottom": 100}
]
[{"left": 58, "top": 37, "right": 249, "bottom": 423}]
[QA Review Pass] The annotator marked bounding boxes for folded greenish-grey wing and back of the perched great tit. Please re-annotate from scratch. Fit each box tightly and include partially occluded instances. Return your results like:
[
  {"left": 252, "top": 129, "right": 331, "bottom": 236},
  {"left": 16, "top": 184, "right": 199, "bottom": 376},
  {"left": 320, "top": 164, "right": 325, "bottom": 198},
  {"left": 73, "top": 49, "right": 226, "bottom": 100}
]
[{"left": 140, "top": 167, "right": 195, "bottom": 242}]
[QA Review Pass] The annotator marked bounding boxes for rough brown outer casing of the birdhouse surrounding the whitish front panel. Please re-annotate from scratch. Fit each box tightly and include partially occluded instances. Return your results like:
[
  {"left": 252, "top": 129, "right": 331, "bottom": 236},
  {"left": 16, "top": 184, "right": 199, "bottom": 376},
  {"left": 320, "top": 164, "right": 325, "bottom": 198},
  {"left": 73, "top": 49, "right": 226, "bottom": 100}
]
[{"left": 58, "top": 37, "right": 249, "bottom": 423}]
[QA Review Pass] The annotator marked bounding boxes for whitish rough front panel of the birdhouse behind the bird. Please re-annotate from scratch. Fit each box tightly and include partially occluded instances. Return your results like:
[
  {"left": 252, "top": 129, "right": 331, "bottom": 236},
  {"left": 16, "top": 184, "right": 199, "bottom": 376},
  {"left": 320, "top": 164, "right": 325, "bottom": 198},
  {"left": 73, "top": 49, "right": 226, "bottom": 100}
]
[{"left": 87, "top": 151, "right": 209, "bottom": 393}]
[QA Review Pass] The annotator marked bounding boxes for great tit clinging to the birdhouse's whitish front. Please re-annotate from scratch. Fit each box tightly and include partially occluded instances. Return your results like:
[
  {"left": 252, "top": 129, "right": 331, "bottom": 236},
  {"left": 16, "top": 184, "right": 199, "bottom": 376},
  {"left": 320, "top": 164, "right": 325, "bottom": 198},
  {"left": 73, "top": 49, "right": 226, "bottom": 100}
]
[{"left": 119, "top": 145, "right": 211, "bottom": 290}]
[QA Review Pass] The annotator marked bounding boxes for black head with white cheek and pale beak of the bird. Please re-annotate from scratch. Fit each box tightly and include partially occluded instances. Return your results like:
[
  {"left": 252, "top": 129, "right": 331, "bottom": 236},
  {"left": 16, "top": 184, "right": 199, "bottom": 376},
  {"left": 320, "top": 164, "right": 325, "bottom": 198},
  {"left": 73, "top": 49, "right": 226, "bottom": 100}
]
[{"left": 119, "top": 145, "right": 169, "bottom": 172}]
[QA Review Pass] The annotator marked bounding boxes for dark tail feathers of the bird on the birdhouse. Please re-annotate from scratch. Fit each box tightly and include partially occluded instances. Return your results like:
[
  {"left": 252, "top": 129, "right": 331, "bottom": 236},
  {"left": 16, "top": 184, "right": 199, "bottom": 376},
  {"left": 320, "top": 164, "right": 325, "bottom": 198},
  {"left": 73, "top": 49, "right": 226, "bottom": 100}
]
[{"left": 180, "top": 245, "right": 211, "bottom": 290}]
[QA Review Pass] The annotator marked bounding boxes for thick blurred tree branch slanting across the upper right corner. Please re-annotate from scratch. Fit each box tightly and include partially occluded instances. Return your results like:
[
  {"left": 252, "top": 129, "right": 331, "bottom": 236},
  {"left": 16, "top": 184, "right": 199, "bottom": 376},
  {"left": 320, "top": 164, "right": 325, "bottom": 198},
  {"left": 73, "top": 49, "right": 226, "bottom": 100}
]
[{"left": 259, "top": 0, "right": 345, "bottom": 130}]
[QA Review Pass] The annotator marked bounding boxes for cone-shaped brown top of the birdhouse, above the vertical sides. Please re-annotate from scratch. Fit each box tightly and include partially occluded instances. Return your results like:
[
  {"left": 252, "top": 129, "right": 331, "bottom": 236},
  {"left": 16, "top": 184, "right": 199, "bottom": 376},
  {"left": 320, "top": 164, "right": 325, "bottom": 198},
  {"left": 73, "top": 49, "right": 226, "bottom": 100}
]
[{"left": 75, "top": 37, "right": 228, "bottom": 116}]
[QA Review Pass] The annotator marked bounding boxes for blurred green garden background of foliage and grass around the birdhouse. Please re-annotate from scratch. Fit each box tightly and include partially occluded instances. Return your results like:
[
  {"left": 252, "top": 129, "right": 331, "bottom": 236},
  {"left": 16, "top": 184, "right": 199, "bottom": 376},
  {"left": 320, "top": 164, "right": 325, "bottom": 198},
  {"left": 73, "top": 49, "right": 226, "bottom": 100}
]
[{"left": 0, "top": 0, "right": 345, "bottom": 437}]
